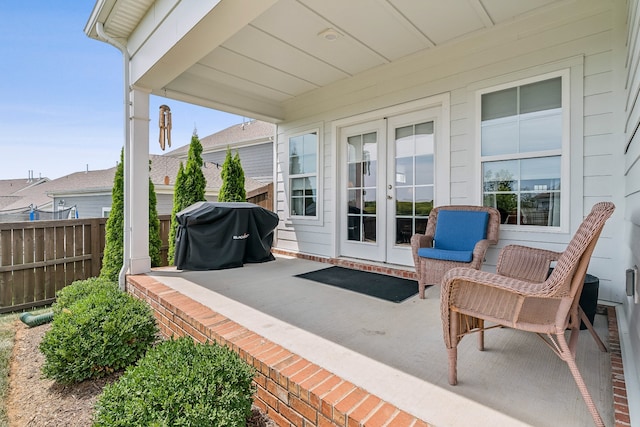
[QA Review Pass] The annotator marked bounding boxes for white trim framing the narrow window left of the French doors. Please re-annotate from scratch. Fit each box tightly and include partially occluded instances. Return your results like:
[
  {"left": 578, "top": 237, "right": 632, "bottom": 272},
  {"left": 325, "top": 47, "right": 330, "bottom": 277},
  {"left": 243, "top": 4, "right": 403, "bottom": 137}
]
[{"left": 283, "top": 124, "right": 323, "bottom": 225}]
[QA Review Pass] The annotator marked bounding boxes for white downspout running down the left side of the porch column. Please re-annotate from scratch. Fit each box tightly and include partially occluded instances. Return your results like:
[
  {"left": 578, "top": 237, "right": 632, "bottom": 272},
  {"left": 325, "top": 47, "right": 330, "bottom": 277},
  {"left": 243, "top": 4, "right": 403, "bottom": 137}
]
[{"left": 96, "top": 22, "right": 131, "bottom": 291}]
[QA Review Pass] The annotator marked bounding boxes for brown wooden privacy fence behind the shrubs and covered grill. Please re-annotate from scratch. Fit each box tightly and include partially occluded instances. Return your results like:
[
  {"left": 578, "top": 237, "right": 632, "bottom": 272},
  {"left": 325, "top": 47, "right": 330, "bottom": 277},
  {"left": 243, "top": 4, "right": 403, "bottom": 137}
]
[{"left": 0, "top": 184, "right": 273, "bottom": 313}]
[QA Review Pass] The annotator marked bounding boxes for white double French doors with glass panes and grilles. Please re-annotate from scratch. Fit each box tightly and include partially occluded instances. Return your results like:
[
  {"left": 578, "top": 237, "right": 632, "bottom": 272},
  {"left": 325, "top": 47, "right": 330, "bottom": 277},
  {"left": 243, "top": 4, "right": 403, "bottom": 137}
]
[{"left": 338, "top": 108, "right": 439, "bottom": 265}]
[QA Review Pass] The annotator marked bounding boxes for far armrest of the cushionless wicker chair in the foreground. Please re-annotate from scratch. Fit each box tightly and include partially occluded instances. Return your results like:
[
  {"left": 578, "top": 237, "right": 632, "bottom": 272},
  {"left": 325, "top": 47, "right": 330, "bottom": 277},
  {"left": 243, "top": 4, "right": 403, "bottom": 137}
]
[{"left": 496, "top": 245, "right": 562, "bottom": 282}]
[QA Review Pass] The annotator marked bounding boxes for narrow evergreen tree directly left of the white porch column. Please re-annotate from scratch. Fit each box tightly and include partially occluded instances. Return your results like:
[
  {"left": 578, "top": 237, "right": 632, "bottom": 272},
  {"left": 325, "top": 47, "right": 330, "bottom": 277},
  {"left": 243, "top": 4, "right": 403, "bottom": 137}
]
[{"left": 100, "top": 149, "right": 124, "bottom": 282}]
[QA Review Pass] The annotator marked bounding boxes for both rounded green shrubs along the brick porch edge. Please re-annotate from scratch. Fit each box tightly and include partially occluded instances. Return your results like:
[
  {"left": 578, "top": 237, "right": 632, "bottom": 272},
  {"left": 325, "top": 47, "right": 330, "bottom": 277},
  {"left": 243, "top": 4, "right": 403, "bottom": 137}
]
[{"left": 40, "top": 278, "right": 255, "bottom": 427}]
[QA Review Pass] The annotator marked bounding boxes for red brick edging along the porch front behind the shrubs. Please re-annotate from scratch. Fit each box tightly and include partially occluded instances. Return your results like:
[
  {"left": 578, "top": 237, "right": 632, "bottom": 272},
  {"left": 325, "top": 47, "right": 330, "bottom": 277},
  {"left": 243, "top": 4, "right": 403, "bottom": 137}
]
[{"left": 127, "top": 275, "right": 429, "bottom": 427}]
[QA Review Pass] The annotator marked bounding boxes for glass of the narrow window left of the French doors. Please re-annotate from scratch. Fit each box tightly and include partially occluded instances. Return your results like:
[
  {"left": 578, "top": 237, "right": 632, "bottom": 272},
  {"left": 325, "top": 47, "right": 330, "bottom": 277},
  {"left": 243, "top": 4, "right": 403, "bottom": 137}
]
[{"left": 289, "top": 132, "right": 318, "bottom": 217}]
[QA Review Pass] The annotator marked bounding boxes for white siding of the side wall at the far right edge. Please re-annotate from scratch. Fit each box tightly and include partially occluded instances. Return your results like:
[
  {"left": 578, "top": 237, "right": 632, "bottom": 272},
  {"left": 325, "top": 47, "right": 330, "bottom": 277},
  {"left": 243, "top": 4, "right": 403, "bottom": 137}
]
[{"left": 620, "top": 0, "right": 640, "bottom": 412}]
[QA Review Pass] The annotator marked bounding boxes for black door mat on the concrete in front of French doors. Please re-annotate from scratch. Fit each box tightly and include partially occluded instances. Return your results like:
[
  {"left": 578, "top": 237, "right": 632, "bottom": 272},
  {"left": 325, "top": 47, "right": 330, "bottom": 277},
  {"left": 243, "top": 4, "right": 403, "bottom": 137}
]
[{"left": 296, "top": 266, "right": 418, "bottom": 303}]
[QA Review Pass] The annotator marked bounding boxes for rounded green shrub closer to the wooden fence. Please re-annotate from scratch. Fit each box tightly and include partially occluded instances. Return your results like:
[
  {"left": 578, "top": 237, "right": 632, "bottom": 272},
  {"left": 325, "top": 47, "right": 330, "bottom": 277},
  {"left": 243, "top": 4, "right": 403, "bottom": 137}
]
[{"left": 40, "top": 284, "right": 157, "bottom": 383}]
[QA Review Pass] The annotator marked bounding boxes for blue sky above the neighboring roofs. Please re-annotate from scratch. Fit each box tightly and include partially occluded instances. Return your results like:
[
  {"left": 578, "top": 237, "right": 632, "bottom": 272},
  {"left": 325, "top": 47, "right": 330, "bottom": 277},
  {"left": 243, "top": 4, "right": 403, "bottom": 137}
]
[{"left": 0, "top": 0, "right": 248, "bottom": 180}]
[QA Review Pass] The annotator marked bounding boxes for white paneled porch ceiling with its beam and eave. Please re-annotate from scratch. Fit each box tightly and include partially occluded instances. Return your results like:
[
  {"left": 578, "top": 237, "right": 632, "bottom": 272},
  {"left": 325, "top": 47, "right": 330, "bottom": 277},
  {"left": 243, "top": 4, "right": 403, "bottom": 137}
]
[{"left": 85, "top": 0, "right": 575, "bottom": 121}]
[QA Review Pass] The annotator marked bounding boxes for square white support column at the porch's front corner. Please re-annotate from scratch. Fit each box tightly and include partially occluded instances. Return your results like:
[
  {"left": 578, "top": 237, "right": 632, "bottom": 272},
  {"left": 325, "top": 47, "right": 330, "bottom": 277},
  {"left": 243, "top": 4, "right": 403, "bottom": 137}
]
[{"left": 125, "top": 87, "right": 151, "bottom": 274}]
